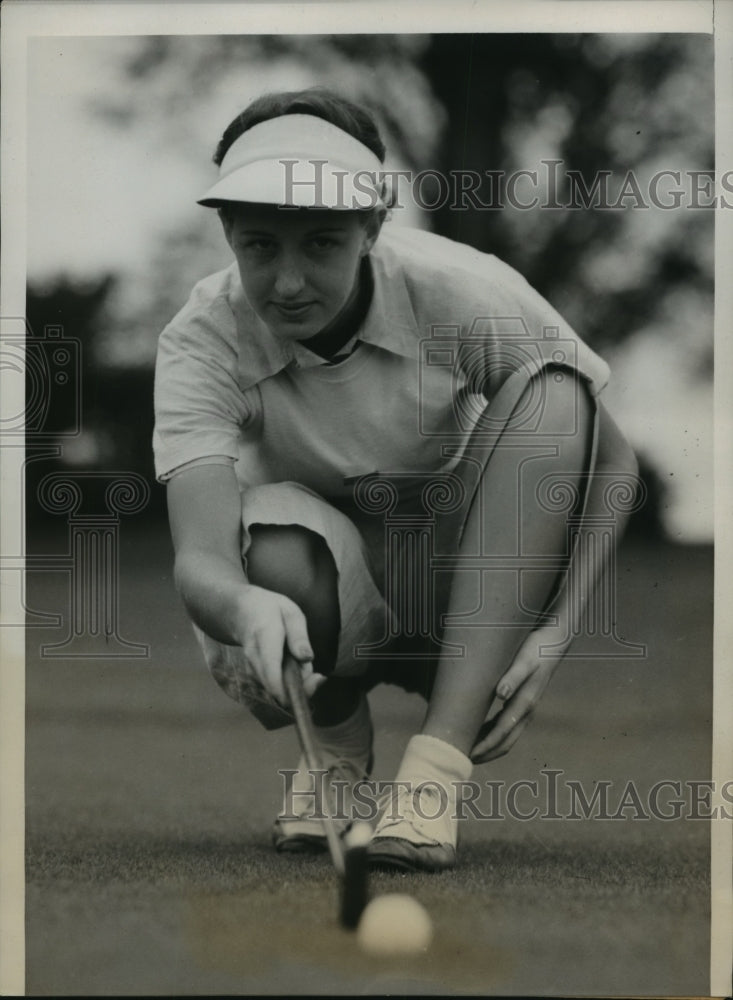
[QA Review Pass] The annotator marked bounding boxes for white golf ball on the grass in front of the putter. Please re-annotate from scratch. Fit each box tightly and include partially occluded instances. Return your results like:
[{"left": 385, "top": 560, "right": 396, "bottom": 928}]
[{"left": 357, "top": 892, "right": 433, "bottom": 955}]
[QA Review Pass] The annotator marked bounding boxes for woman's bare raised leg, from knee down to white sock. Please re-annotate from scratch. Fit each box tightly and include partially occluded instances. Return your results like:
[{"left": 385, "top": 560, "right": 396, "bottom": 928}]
[{"left": 422, "top": 373, "right": 593, "bottom": 755}]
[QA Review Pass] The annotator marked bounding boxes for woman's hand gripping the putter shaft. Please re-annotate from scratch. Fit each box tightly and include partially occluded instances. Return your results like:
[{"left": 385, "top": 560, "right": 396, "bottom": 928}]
[{"left": 236, "top": 584, "right": 326, "bottom": 708}]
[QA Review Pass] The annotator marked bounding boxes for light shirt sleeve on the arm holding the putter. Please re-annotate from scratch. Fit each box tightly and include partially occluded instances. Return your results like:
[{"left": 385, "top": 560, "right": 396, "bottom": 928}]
[{"left": 153, "top": 290, "right": 255, "bottom": 482}]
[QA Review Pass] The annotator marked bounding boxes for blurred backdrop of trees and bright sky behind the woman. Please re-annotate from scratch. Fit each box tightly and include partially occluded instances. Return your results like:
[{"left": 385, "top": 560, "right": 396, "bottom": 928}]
[{"left": 27, "top": 34, "right": 714, "bottom": 542}]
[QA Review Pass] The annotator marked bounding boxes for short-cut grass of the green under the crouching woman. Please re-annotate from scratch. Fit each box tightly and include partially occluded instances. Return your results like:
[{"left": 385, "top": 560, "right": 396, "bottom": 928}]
[{"left": 27, "top": 529, "right": 712, "bottom": 996}]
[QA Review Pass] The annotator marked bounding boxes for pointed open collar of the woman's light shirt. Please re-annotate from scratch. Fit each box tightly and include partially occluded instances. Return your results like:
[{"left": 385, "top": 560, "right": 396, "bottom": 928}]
[{"left": 228, "top": 237, "right": 425, "bottom": 391}]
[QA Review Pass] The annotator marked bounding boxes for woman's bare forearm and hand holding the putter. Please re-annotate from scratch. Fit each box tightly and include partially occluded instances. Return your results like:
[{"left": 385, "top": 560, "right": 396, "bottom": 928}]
[{"left": 167, "top": 465, "right": 323, "bottom": 704}]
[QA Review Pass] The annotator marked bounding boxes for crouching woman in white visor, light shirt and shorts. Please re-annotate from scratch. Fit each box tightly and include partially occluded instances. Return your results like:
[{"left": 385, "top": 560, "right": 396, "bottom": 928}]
[{"left": 155, "top": 90, "right": 635, "bottom": 871}]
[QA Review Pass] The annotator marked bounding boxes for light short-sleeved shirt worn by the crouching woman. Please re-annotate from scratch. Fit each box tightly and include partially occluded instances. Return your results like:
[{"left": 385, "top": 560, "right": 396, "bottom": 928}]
[{"left": 154, "top": 226, "right": 609, "bottom": 498}]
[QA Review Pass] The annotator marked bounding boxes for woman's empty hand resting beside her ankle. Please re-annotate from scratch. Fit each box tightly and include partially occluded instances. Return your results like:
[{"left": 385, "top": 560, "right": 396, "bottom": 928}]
[{"left": 471, "top": 625, "right": 570, "bottom": 764}]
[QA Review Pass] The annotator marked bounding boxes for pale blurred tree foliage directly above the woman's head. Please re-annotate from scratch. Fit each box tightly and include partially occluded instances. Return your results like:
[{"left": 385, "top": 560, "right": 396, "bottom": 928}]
[{"left": 91, "top": 34, "right": 445, "bottom": 165}]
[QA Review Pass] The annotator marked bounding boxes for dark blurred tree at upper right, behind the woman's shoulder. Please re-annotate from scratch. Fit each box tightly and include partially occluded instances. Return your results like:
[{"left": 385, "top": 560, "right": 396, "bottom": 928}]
[{"left": 421, "top": 34, "right": 714, "bottom": 358}]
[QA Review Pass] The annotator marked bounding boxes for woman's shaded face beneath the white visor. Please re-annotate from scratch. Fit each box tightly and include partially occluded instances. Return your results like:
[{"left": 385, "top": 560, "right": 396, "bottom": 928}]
[{"left": 222, "top": 205, "right": 376, "bottom": 340}]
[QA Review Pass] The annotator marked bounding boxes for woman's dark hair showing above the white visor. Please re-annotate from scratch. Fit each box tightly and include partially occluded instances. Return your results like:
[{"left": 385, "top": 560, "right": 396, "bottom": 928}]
[{"left": 214, "top": 87, "right": 386, "bottom": 166}]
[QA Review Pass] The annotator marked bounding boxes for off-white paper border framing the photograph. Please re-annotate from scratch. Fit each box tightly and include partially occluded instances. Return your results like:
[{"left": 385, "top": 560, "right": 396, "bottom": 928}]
[{"left": 0, "top": 0, "right": 733, "bottom": 996}]
